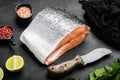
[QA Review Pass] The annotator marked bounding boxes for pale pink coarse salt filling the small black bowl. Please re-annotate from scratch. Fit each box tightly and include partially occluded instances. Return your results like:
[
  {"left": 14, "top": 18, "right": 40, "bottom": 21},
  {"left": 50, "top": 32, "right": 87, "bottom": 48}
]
[{"left": 17, "top": 6, "right": 32, "bottom": 18}]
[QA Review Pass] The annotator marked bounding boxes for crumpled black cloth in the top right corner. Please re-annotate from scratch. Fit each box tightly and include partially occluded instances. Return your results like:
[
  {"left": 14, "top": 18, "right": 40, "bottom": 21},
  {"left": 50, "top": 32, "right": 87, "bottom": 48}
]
[{"left": 79, "top": 0, "right": 120, "bottom": 47}]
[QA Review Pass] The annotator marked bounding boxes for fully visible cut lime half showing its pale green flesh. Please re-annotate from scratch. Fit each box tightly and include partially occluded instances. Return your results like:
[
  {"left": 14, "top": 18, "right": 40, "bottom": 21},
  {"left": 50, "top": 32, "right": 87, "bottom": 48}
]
[{"left": 5, "top": 55, "right": 24, "bottom": 72}]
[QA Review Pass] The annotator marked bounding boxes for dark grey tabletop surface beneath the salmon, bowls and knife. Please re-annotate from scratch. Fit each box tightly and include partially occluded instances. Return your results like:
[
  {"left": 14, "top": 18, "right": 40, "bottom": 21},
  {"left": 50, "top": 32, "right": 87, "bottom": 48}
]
[{"left": 0, "top": 0, "right": 120, "bottom": 80}]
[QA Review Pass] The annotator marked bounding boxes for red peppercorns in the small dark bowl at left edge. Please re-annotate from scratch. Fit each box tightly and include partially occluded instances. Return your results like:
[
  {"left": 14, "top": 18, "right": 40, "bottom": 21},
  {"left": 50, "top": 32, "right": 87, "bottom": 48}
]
[{"left": 0, "top": 26, "right": 13, "bottom": 39}]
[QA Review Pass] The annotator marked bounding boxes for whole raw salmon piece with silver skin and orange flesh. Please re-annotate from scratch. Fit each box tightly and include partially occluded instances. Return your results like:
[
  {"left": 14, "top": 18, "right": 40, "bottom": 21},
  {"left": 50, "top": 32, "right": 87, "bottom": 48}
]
[{"left": 20, "top": 8, "right": 90, "bottom": 65}]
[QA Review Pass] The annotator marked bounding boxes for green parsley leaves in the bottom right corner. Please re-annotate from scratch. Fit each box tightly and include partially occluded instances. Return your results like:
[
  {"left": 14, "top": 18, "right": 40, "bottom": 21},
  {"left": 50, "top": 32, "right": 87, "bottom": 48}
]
[{"left": 89, "top": 58, "right": 120, "bottom": 80}]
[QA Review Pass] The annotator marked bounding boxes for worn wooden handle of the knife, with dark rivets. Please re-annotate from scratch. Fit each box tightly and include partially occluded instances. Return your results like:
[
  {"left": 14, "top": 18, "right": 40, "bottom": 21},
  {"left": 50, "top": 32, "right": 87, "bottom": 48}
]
[{"left": 48, "top": 55, "right": 84, "bottom": 76}]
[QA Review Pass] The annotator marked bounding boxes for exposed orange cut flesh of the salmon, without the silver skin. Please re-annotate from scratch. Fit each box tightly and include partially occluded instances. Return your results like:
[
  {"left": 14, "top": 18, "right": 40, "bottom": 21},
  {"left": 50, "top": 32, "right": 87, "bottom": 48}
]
[{"left": 45, "top": 26, "right": 90, "bottom": 65}]
